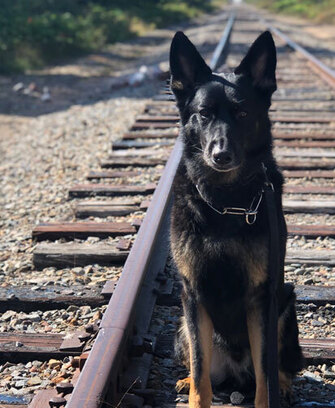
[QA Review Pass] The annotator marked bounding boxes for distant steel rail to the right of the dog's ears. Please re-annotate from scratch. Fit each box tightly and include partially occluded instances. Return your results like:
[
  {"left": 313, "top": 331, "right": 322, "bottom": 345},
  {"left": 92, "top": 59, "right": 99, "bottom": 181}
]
[{"left": 270, "top": 22, "right": 335, "bottom": 88}]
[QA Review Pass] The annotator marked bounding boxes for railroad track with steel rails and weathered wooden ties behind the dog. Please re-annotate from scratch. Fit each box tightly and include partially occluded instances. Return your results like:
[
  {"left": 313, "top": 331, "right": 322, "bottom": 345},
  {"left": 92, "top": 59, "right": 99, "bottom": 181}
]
[{"left": 0, "top": 4, "right": 335, "bottom": 408}]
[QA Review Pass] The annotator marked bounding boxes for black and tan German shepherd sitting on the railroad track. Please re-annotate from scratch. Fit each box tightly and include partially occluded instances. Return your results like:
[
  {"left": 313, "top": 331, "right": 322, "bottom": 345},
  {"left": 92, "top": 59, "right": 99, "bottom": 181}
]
[{"left": 170, "top": 32, "right": 302, "bottom": 408}]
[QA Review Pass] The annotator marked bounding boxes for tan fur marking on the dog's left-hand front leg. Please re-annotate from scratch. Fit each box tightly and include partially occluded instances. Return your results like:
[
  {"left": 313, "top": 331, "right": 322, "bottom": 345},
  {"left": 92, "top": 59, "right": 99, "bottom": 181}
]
[{"left": 189, "top": 305, "right": 213, "bottom": 408}]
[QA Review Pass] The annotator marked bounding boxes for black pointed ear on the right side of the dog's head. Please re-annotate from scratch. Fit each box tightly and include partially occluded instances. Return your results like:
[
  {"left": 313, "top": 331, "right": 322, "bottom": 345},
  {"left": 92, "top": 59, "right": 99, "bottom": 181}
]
[{"left": 235, "top": 31, "right": 277, "bottom": 95}]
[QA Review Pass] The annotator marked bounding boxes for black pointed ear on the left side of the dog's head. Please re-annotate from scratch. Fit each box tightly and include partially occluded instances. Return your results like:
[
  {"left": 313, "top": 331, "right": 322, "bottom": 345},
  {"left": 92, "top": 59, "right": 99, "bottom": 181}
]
[{"left": 170, "top": 31, "right": 212, "bottom": 99}]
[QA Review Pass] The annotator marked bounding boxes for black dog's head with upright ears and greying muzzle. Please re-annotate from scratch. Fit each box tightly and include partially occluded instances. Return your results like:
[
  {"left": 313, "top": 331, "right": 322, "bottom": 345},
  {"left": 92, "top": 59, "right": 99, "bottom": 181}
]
[{"left": 170, "top": 31, "right": 276, "bottom": 183}]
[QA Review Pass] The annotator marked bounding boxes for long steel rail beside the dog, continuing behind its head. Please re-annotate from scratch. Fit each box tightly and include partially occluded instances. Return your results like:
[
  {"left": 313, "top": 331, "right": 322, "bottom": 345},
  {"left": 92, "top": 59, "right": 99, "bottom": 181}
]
[{"left": 67, "top": 15, "right": 235, "bottom": 408}]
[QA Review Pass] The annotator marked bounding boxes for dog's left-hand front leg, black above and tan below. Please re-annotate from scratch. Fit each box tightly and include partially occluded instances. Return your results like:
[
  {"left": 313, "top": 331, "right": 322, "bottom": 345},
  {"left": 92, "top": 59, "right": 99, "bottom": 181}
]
[{"left": 183, "top": 294, "right": 213, "bottom": 408}]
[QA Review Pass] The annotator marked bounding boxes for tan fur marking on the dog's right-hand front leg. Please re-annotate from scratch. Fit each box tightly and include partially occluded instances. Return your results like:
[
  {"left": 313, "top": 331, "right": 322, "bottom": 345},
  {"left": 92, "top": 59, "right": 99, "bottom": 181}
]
[{"left": 247, "top": 308, "right": 268, "bottom": 408}]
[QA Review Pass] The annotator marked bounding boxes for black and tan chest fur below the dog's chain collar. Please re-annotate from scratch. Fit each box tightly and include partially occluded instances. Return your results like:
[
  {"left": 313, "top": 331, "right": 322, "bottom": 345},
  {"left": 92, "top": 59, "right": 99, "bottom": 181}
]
[{"left": 171, "top": 166, "right": 268, "bottom": 296}]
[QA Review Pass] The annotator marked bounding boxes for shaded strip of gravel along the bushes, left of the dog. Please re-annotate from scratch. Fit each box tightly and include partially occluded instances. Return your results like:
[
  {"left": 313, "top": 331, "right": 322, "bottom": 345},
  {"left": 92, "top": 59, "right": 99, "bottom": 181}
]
[{"left": 0, "top": 12, "right": 226, "bottom": 117}]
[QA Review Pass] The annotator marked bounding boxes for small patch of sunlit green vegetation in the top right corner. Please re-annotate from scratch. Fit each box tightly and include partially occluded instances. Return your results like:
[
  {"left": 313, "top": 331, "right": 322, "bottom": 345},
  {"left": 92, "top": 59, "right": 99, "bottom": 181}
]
[{"left": 248, "top": 0, "right": 335, "bottom": 23}]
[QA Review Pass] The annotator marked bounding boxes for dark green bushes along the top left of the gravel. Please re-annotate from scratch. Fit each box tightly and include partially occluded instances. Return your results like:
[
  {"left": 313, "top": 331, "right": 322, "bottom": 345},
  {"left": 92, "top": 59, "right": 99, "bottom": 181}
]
[{"left": 0, "top": 0, "right": 217, "bottom": 73}]
